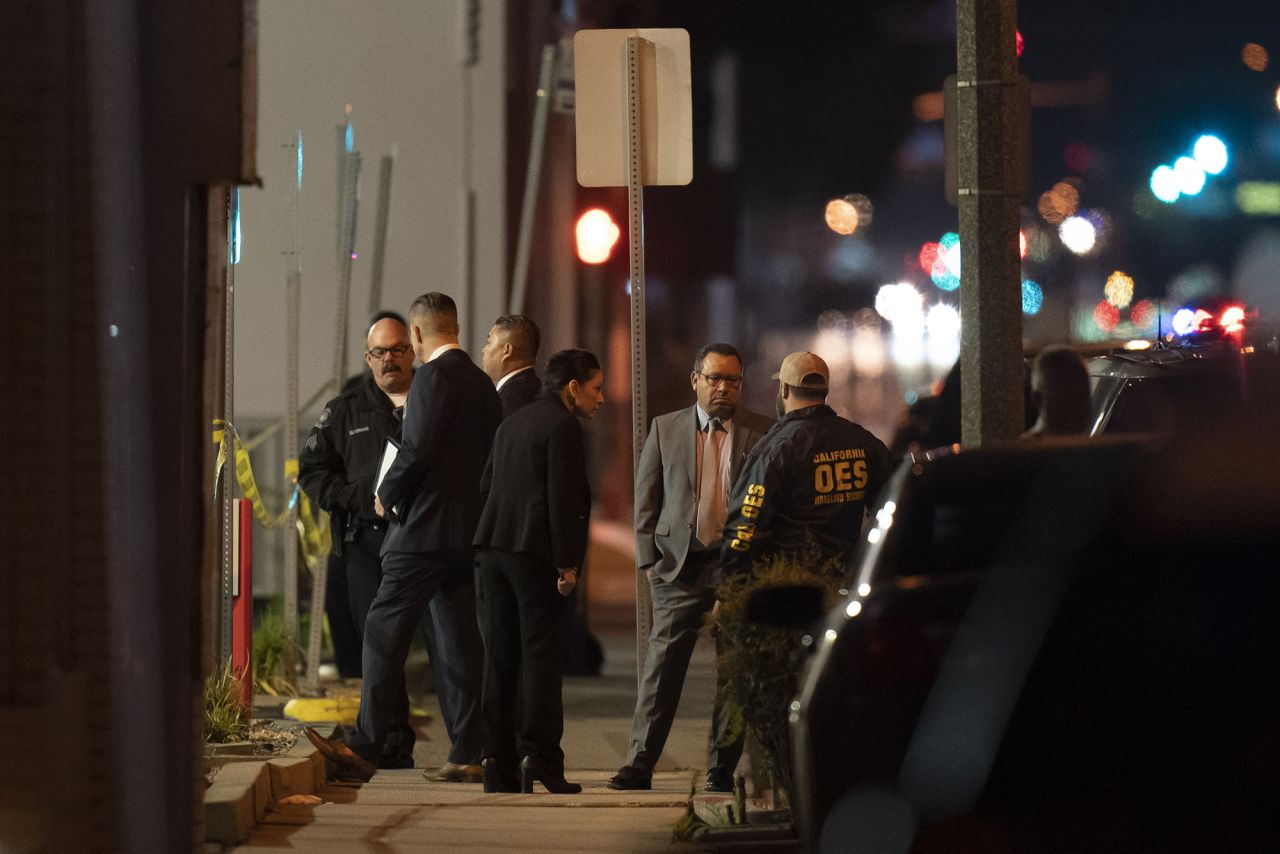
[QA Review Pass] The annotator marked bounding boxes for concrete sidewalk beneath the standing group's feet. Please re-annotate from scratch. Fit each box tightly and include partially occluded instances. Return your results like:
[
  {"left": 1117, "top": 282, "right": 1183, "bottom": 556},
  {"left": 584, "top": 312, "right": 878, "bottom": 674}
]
[{"left": 221, "top": 629, "right": 768, "bottom": 854}]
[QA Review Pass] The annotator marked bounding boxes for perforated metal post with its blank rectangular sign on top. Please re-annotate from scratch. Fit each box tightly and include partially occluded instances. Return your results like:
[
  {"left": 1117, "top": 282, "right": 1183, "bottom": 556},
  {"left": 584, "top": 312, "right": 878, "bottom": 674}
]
[{"left": 573, "top": 29, "right": 694, "bottom": 685}]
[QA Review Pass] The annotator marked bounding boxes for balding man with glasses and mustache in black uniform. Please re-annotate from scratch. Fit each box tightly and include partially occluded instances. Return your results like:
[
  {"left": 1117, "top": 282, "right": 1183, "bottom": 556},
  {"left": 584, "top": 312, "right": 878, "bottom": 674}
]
[{"left": 298, "top": 320, "right": 413, "bottom": 747}]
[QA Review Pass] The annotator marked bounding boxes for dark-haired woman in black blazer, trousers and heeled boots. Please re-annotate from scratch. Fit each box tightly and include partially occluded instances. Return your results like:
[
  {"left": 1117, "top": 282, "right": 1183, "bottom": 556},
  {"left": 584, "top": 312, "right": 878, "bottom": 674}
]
[{"left": 475, "top": 350, "right": 604, "bottom": 794}]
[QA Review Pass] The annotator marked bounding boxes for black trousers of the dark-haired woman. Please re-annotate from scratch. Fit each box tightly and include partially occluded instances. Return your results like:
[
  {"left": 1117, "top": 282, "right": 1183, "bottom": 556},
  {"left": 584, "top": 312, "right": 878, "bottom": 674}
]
[{"left": 476, "top": 549, "right": 564, "bottom": 773}]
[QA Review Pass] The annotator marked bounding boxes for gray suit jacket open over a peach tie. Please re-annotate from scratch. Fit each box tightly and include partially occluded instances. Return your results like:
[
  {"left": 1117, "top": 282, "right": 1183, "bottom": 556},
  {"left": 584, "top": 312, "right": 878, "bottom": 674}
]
[{"left": 635, "top": 405, "right": 772, "bottom": 581}]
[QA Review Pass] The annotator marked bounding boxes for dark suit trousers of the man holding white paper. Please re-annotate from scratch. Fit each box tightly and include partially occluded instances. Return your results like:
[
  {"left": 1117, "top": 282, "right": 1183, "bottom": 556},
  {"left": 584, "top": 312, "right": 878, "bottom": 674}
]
[{"left": 347, "top": 549, "right": 484, "bottom": 764}]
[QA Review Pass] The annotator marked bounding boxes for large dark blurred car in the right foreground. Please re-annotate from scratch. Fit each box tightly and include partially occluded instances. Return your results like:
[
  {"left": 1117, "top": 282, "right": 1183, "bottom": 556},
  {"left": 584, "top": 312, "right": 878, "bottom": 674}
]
[{"left": 791, "top": 421, "right": 1280, "bottom": 854}]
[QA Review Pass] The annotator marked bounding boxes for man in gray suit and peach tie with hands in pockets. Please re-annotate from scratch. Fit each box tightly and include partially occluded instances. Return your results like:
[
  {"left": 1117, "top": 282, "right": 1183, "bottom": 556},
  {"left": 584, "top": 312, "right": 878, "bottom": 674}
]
[{"left": 608, "top": 343, "right": 769, "bottom": 791}]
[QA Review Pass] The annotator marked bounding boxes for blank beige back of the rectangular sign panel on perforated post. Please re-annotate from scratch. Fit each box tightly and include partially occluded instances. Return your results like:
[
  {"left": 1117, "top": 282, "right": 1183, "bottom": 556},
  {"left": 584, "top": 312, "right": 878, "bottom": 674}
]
[{"left": 573, "top": 28, "right": 694, "bottom": 187}]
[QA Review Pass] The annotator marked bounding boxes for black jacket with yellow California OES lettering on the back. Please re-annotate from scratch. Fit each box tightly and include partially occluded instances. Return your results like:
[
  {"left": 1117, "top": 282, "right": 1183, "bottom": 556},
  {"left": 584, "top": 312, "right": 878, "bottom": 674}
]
[{"left": 721, "top": 403, "right": 890, "bottom": 572}]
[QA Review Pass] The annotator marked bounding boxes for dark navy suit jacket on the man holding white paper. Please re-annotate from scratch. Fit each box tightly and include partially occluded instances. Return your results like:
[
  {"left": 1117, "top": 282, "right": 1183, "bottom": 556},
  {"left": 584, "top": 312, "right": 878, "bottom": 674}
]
[{"left": 378, "top": 350, "right": 502, "bottom": 553}]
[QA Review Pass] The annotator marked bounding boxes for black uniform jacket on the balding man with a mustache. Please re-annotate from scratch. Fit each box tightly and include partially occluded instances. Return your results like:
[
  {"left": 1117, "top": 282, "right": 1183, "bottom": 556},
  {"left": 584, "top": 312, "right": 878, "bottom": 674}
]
[{"left": 298, "top": 371, "right": 401, "bottom": 554}]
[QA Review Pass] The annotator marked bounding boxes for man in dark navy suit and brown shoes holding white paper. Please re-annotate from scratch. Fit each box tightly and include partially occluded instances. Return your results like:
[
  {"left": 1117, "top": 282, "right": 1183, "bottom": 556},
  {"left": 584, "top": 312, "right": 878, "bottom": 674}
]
[{"left": 307, "top": 293, "right": 502, "bottom": 782}]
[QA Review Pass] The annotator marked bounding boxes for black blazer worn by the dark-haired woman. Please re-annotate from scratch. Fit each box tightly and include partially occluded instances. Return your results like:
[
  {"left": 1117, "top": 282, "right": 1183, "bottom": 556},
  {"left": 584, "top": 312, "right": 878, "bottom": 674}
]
[{"left": 474, "top": 392, "right": 591, "bottom": 568}]
